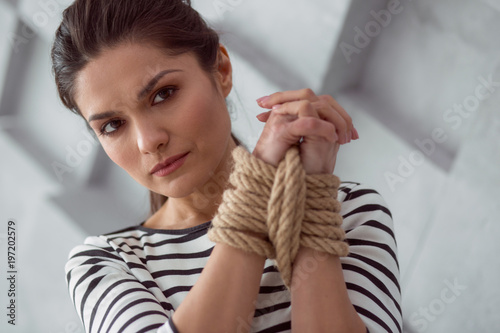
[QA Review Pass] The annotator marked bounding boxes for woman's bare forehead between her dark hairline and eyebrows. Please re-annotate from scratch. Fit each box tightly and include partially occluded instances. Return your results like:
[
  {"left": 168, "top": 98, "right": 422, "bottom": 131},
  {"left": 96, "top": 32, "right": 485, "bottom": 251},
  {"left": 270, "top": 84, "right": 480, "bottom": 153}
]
[{"left": 75, "top": 44, "right": 201, "bottom": 119}]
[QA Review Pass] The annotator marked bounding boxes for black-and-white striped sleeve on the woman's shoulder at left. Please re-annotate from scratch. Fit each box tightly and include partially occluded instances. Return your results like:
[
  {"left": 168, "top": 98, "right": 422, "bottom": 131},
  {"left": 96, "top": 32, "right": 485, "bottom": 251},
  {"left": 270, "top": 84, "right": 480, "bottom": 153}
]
[{"left": 65, "top": 237, "right": 176, "bottom": 333}]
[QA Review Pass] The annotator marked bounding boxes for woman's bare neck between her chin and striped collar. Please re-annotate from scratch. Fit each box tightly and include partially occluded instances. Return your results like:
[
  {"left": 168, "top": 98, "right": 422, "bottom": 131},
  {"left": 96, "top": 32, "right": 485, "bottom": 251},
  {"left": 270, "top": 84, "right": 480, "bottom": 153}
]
[{"left": 145, "top": 138, "right": 236, "bottom": 229}]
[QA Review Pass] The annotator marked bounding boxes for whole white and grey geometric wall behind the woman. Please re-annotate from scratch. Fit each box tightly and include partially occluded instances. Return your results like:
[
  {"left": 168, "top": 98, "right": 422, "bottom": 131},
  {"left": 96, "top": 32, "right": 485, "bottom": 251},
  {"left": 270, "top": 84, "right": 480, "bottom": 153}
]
[{"left": 0, "top": 0, "right": 500, "bottom": 332}]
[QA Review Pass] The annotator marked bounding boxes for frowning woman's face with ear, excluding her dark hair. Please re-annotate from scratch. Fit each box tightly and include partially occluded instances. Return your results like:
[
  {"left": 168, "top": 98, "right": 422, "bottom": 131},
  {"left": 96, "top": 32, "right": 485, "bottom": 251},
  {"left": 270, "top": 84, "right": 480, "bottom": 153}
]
[{"left": 75, "top": 44, "right": 232, "bottom": 198}]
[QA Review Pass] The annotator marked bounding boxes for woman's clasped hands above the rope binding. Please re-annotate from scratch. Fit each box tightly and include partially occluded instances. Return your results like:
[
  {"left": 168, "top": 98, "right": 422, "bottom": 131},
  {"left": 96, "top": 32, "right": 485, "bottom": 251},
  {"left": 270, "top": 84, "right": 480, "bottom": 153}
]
[{"left": 253, "top": 89, "right": 359, "bottom": 174}]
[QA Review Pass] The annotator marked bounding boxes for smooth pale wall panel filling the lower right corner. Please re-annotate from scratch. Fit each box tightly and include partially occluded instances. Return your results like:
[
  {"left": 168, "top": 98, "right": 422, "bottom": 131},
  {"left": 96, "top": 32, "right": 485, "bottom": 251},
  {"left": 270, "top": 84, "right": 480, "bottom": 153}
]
[{"left": 404, "top": 99, "right": 500, "bottom": 333}]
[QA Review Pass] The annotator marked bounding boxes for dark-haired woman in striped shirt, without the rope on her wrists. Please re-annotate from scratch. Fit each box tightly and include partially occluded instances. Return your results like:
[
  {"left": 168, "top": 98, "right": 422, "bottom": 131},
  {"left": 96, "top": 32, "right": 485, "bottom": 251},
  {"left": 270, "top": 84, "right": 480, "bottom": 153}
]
[{"left": 52, "top": 0, "right": 401, "bottom": 333}]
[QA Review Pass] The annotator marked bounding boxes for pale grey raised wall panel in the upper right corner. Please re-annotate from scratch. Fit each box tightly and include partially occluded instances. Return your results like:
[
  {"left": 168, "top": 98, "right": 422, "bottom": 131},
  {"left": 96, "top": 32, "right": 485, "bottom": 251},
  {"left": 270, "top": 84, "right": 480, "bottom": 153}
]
[{"left": 361, "top": 0, "right": 500, "bottom": 170}]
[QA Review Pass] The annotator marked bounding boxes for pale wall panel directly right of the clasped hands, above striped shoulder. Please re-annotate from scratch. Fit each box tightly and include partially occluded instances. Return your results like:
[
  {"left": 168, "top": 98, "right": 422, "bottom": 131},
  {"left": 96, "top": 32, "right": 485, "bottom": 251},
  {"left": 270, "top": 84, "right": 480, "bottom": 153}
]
[{"left": 335, "top": 92, "right": 447, "bottom": 290}]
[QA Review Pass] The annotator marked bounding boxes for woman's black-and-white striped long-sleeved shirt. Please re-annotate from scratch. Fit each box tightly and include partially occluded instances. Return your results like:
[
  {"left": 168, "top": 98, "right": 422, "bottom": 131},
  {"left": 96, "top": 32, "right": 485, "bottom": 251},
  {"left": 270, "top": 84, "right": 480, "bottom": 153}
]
[{"left": 66, "top": 182, "right": 402, "bottom": 333}]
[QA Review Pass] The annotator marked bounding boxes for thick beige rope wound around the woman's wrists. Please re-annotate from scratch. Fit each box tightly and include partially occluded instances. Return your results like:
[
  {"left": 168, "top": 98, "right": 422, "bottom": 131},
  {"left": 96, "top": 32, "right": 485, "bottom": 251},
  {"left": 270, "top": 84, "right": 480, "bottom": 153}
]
[{"left": 208, "top": 147, "right": 349, "bottom": 287}]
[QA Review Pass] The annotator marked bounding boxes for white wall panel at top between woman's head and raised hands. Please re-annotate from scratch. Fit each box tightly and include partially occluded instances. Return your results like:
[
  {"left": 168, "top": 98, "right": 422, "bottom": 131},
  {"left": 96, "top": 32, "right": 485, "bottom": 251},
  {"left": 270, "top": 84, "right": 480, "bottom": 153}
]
[{"left": 194, "top": 0, "right": 351, "bottom": 90}]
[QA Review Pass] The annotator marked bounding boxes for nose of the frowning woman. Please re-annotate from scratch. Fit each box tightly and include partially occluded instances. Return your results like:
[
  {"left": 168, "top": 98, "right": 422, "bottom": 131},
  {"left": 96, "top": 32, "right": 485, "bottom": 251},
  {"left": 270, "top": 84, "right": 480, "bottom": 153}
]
[{"left": 136, "top": 119, "right": 170, "bottom": 154}]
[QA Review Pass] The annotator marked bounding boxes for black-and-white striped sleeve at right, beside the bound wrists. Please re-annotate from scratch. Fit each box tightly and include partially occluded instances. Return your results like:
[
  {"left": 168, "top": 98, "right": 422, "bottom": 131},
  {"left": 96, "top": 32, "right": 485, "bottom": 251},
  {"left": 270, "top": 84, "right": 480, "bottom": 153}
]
[{"left": 339, "top": 183, "right": 402, "bottom": 333}]
